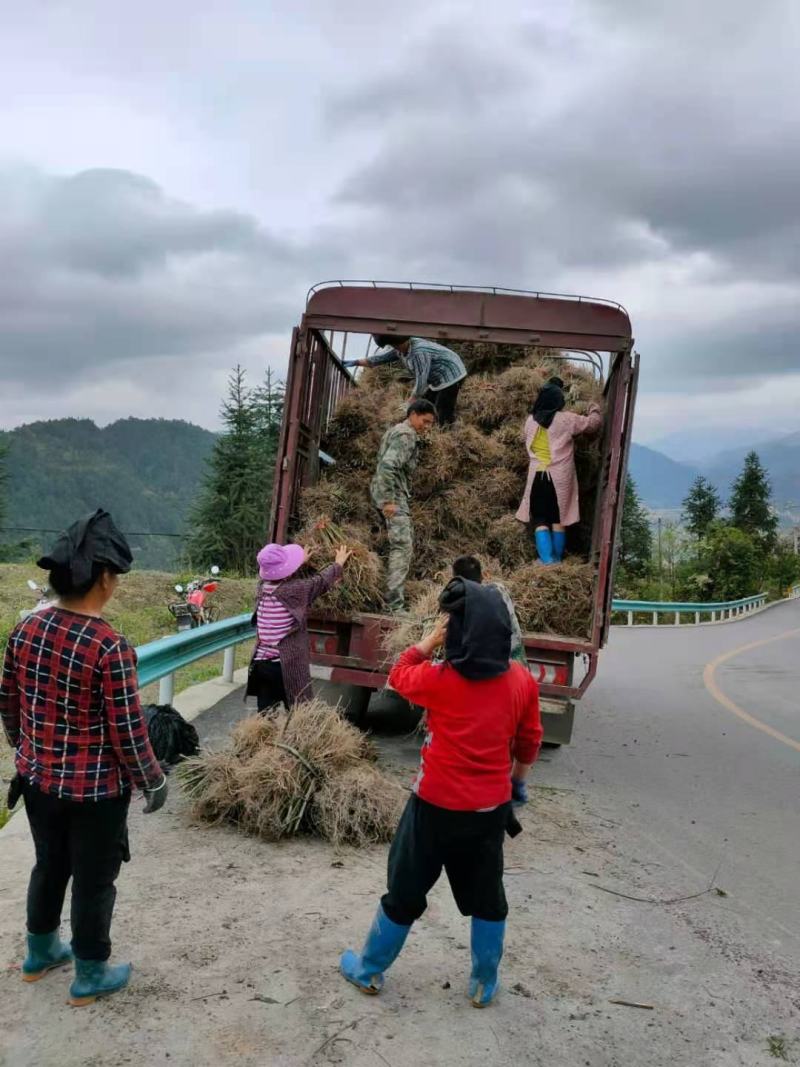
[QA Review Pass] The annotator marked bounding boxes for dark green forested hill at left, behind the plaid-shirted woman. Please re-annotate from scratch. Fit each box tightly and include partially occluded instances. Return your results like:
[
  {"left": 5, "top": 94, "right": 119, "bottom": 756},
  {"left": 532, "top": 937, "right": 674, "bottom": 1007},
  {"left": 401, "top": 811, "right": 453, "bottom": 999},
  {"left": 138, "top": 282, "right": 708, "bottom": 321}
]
[{"left": 0, "top": 418, "right": 214, "bottom": 568}]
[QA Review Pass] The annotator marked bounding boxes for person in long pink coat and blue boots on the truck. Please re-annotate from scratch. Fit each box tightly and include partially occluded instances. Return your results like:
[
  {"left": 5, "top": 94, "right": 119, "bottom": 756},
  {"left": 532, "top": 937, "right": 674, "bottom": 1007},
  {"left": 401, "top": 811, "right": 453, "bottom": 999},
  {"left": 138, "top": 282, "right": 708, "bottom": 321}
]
[{"left": 516, "top": 378, "right": 603, "bottom": 563}]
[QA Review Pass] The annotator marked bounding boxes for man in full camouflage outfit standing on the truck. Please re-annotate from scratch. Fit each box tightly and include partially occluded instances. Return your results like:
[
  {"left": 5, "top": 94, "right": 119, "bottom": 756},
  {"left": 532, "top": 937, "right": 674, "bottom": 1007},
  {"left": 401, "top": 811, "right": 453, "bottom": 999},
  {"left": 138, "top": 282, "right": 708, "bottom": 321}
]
[{"left": 370, "top": 400, "right": 436, "bottom": 611}]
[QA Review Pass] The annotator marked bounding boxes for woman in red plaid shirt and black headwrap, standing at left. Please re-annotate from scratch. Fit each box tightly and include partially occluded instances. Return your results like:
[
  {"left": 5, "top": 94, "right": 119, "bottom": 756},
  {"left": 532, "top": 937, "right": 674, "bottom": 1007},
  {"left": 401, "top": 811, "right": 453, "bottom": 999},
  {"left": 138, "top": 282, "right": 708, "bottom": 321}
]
[{"left": 0, "top": 510, "right": 166, "bottom": 1005}]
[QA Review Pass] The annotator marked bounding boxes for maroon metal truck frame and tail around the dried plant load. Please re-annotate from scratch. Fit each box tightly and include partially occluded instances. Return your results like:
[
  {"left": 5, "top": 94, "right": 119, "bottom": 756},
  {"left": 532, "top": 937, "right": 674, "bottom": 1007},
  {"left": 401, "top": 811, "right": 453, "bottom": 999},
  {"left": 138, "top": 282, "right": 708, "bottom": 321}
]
[{"left": 271, "top": 282, "right": 638, "bottom": 744}]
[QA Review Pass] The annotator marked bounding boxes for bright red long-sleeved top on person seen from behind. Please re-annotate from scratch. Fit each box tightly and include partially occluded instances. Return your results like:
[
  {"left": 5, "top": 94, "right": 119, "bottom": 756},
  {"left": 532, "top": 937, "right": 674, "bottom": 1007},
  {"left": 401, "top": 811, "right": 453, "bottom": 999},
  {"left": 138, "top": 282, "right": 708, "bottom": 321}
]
[{"left": 389, "top": 648, "right": 543, "bottom": 811}]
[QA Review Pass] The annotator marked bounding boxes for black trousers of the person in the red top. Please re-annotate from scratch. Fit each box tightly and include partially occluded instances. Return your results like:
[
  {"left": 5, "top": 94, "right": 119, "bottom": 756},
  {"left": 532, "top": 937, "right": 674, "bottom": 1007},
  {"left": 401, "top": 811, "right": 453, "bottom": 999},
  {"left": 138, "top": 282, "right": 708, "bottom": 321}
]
[{"left": 381, "top": 796, "right": 511, "bottom": 926}]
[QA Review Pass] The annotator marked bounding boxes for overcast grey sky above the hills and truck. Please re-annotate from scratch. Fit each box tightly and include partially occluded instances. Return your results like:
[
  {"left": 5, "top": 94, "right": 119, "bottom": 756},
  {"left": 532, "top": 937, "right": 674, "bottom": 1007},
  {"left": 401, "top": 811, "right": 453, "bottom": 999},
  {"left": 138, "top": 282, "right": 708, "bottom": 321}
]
[{"left": 0, "top": 0, "right": 800, "bottom": 451}]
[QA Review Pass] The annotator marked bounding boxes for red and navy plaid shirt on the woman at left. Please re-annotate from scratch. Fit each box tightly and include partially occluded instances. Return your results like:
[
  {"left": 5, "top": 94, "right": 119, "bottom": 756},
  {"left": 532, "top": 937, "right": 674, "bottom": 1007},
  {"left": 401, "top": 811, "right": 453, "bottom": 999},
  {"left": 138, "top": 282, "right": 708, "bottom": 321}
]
[{"left": 0, "top": 608, "right": 163, "bottom": 800}]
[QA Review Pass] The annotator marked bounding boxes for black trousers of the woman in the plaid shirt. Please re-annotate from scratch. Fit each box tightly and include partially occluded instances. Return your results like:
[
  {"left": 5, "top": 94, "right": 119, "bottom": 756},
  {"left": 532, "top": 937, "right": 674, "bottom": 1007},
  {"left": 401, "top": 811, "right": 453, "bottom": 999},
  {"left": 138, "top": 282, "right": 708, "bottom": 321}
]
[{"left": 22, "top": 782, "right": 130, "bottom": 960}]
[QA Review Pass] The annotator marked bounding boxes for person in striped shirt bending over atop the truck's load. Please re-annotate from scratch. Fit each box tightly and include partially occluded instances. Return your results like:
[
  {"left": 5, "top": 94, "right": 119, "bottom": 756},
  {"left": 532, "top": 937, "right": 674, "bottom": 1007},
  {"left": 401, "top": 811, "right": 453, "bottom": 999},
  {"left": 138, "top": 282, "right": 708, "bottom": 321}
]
[{"left": 350, "top": 334, "right": 467, "bottom": 427}]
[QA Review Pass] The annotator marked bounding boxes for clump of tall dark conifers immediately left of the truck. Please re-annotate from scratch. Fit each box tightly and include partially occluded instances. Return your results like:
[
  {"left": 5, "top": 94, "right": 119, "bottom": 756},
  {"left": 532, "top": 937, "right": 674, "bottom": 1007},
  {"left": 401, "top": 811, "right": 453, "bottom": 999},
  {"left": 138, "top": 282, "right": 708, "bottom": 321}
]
[{"left": 187, "top": 366, "right": 283, "bottom": 574}]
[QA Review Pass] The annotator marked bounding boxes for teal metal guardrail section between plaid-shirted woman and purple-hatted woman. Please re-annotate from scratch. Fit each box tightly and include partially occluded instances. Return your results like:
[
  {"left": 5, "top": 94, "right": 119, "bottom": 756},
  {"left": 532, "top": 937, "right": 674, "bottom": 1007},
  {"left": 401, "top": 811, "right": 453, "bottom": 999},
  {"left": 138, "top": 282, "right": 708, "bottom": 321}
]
[{"left": 137, "top": 615, "right": 255, "bottom": 704}]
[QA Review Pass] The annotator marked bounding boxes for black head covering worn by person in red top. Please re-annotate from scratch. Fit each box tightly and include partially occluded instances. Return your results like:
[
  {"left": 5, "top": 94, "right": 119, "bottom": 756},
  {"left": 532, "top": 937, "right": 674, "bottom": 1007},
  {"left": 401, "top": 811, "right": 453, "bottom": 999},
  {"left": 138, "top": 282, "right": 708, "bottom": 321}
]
[{"left": 439, "top": 578, "right": 511, "bottom": 681}]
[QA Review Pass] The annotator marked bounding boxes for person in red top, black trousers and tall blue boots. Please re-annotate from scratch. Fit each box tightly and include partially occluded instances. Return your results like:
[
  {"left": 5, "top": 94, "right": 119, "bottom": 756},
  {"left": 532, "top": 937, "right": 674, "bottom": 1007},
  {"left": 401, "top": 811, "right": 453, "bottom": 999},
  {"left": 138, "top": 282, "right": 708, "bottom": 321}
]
[{"left": 340, "top": 578, "right": 542, "bottom": 1007}]
